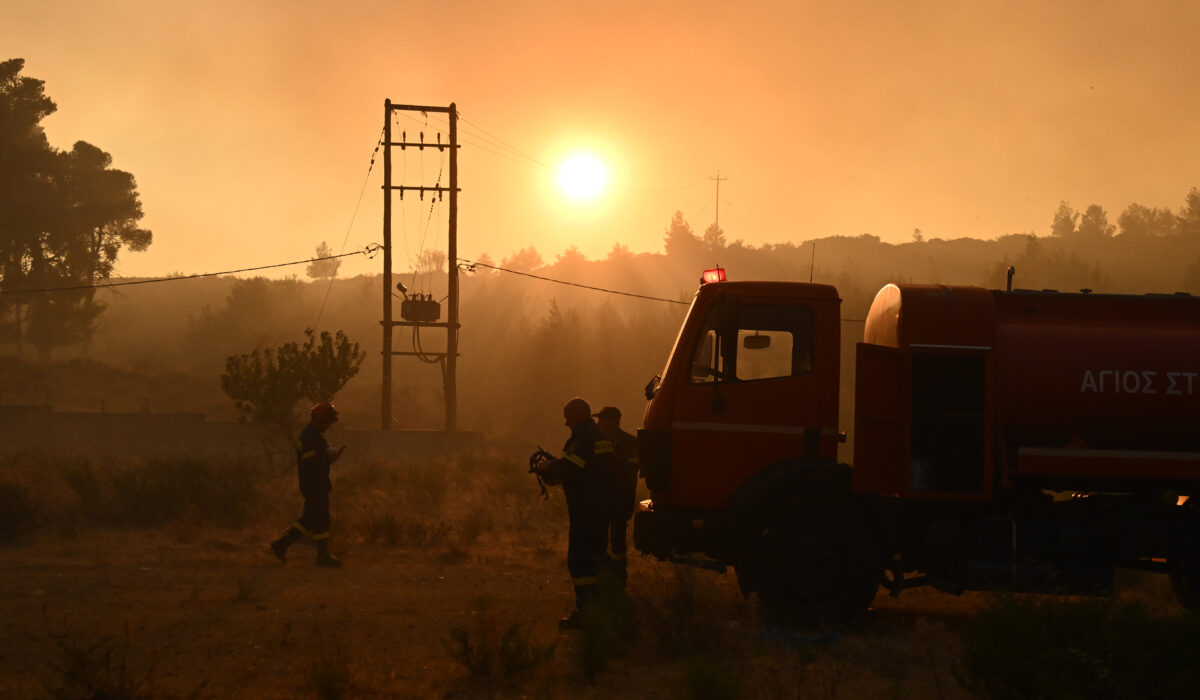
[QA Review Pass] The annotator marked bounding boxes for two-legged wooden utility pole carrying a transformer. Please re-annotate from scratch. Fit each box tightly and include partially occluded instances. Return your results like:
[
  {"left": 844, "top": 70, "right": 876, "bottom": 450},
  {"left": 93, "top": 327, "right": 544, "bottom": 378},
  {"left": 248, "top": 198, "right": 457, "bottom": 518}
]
[{"left": 379, "top": 100, "right": 460, "bottom": 432}]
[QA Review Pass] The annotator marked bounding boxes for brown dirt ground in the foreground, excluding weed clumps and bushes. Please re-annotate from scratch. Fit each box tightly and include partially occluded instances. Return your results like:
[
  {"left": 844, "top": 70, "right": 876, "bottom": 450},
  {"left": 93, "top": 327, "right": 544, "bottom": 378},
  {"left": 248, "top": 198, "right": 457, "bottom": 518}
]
[{"left": 0, "top": 528, "right": 1012, "bottom": 698}]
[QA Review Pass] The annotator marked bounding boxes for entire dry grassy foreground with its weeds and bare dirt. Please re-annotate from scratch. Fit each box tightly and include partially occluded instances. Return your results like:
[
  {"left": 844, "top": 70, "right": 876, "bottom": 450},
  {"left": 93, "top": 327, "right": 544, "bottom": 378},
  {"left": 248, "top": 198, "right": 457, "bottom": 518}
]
[{"left": 0, "top": 451, "right": 1200, "bottom": 698}]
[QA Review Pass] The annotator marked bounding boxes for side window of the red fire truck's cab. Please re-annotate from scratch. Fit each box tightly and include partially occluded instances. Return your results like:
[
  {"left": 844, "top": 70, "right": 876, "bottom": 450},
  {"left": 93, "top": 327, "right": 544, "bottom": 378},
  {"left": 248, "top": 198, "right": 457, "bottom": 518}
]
[{"left": 689, "top": 304, "right": 814, "bottom": 384}]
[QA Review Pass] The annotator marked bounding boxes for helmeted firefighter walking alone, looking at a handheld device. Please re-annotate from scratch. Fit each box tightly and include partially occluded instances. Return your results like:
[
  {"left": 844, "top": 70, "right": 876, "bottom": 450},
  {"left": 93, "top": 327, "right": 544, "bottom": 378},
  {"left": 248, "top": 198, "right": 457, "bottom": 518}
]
[{"left": 271, "top": 401, "right": 346, "bottom": 567}]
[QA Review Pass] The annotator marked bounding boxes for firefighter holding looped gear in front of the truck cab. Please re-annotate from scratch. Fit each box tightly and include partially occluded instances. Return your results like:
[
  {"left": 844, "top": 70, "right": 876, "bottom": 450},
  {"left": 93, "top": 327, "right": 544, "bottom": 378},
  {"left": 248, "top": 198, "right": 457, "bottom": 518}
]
[{"left": 538, "top": 397, "right": 613, "bottom": 629}]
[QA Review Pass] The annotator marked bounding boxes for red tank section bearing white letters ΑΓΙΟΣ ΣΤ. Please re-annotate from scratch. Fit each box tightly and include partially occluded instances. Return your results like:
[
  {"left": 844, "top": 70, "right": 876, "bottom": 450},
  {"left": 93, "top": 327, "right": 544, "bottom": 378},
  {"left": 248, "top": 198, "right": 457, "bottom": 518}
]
[{"left": 994, "top": 292, "right": 1200, "bottom": 451}]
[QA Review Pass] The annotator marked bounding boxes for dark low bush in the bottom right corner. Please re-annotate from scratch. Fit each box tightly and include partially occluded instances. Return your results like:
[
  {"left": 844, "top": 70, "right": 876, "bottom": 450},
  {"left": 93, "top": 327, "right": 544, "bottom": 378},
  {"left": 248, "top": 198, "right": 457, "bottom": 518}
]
[{"left": 959, "top": 597, "right": 1200, "bottom": 699}]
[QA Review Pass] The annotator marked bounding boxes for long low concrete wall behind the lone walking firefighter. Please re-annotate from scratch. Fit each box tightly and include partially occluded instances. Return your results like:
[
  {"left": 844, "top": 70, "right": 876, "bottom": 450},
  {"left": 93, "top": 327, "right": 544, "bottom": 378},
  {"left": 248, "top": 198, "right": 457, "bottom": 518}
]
[{"left": 0, "top": 406, "right": 484, "bottom": 461}]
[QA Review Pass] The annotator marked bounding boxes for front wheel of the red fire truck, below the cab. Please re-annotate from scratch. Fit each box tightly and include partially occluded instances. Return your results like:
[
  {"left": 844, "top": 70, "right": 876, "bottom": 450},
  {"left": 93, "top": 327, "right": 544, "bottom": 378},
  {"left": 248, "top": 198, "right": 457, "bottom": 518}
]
[{"left": 734, "top": 493, "right": 881, "bottom": 624}]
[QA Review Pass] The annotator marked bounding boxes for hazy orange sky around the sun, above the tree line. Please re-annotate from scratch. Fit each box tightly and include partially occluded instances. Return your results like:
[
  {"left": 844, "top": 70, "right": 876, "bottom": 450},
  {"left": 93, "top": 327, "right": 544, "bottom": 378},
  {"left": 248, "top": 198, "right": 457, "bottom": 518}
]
[{"left": 0, "top": 0, "right": 1200, "bottom": 276}]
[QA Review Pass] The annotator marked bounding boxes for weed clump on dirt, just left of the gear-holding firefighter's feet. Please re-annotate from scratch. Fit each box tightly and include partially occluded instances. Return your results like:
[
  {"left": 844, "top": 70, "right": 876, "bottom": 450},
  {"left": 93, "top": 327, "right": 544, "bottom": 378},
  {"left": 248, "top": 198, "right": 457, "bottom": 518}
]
[{"left": 442, "top": 603, "right": 554, "bottom": 688}]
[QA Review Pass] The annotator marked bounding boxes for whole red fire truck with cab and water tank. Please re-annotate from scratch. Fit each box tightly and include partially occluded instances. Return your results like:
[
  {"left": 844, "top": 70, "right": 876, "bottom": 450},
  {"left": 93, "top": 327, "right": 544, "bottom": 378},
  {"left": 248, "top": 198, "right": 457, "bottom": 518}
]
[{"left": 634, "top": 269, "right": 1200, "bottom": 621}]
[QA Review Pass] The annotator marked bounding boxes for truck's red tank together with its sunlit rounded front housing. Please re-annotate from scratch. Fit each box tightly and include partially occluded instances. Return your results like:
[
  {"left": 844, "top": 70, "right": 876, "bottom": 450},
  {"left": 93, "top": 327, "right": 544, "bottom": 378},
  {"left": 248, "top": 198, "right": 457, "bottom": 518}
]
[{"left": 864, "top": 285, "right": 1200, "bottom": 451}]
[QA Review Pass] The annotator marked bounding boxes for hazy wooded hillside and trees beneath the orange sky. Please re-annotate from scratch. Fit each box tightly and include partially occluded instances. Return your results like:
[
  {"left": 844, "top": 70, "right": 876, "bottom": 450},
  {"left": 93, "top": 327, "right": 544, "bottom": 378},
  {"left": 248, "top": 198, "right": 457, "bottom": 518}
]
[{"left": 0, "top": 59, "right": 1200, "bottom": 438}]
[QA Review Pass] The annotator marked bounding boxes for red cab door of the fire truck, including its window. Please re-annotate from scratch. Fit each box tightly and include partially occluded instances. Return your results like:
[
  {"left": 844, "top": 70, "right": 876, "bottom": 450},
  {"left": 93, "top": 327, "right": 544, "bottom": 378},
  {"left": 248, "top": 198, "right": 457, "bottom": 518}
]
[{"left": 671, "top": 299, "right": 838, "bottom": 507}]
